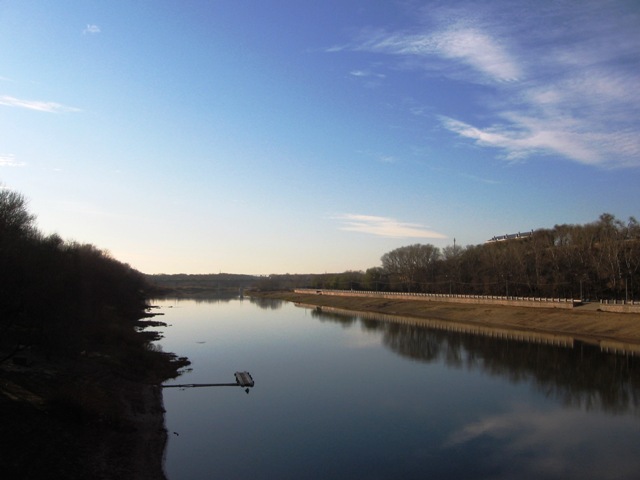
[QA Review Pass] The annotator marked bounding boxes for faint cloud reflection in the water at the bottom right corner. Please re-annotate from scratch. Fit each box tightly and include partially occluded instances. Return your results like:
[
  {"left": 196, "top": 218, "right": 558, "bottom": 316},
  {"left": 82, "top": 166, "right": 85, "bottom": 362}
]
[{"left": 445, "top": 406, "right": 640, "bottom": 480}]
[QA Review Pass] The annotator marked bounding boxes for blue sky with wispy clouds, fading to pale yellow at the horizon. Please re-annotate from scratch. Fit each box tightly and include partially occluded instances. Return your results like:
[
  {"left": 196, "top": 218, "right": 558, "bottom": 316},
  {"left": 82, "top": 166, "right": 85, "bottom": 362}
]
[{"left": 0, "top": 0, "right": 640, "bottom": 275}]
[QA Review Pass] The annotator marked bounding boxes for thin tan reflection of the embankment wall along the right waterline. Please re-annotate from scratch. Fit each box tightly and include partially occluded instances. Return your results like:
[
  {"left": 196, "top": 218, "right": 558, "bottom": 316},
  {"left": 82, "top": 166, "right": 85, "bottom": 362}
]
[{"left": 296, "top": 303, "right": 640, "bottom": 355}]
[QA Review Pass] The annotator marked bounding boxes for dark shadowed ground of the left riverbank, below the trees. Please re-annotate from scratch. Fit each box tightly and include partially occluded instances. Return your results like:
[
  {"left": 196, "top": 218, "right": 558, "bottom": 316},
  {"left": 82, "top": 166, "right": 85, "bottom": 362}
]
[{"left": 0, "top": 322, "right": 188, "bottom": 480}]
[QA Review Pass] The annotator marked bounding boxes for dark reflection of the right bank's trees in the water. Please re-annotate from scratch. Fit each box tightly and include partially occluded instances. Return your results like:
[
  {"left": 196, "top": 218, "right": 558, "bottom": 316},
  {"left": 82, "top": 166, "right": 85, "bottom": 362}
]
[{"left": 315, "top": 312, "right": 640, "bottom": 415}]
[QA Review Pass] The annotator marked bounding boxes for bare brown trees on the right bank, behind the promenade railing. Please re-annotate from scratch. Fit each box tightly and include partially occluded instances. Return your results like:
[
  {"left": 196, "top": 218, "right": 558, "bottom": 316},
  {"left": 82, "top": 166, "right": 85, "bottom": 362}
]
[{"left": 309, "top": 214, "right": 640, "bottom": 300}]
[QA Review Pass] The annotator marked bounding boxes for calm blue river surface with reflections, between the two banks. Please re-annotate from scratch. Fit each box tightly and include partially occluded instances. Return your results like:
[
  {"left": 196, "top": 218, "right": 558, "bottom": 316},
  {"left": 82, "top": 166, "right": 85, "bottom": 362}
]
[{"left": 155, "top": 299, "right": 640, "bottom": 480}]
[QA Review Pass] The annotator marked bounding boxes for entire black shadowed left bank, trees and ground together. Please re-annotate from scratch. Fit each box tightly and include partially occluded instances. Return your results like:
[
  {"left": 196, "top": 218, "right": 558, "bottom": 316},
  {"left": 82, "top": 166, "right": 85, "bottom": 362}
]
[{"left": 0, "top": 190, "right": 189, "bottom": 479}]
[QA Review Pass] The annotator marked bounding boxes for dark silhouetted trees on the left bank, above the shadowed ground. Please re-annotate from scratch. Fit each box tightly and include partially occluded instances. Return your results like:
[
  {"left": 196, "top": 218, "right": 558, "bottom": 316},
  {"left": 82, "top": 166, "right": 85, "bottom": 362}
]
[{"left": 0, "top": 189, "right": 175, "bottom": 368}]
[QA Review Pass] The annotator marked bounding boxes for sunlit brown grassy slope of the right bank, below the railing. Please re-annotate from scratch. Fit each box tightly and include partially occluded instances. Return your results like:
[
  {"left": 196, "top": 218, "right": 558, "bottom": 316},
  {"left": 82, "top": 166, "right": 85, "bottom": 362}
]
[{"left": 246, "top": 291, "right": 640, "bottom": 346}]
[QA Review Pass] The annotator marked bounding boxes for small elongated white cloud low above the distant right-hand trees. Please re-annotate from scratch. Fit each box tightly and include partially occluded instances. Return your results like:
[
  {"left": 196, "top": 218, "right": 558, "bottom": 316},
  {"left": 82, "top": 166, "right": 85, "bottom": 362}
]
[{"left": 334, "top": 213, "right": 447, "bottom": 238}]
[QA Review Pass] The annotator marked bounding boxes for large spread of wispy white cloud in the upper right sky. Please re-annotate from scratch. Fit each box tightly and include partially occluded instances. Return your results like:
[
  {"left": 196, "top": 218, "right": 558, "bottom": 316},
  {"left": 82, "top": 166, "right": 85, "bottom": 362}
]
[{"left": 330, "top": 0, "right": 640, "bottom": 168}]
